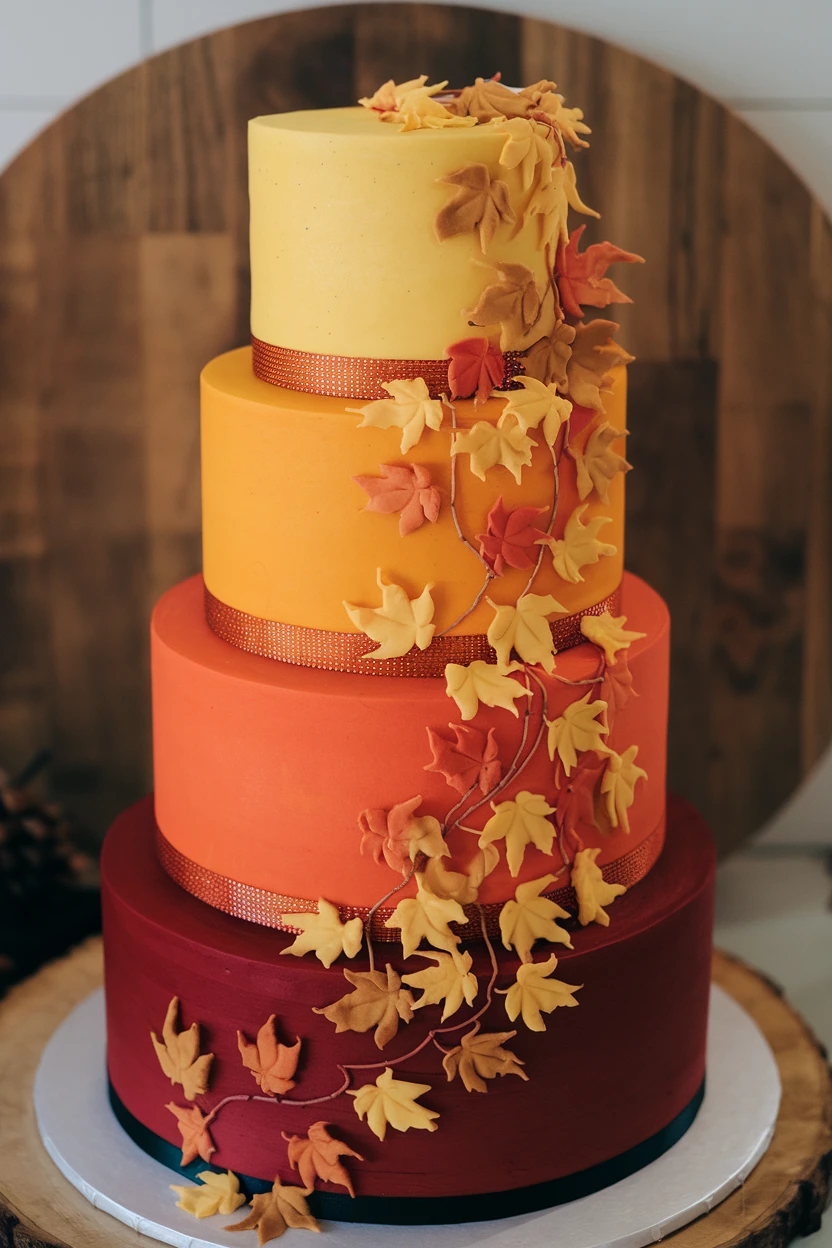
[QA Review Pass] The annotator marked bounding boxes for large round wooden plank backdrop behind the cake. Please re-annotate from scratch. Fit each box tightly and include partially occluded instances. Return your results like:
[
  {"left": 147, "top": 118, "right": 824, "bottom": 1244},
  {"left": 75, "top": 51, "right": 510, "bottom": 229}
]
[{"left": 0, "top": 4, "right": 832, "bottom": 850}]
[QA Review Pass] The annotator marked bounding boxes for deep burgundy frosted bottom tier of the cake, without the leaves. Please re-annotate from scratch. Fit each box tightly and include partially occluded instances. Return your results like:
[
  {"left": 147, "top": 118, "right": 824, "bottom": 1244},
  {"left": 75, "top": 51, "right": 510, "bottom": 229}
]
[{"left": 102, "top": 779, "right": 713, "bottom": 1196}]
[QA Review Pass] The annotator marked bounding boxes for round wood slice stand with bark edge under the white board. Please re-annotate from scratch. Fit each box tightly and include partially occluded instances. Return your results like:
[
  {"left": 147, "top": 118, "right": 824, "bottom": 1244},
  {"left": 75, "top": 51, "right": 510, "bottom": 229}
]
[{"left": 0, "top": 940, "right": 832, "bottom": 1248}]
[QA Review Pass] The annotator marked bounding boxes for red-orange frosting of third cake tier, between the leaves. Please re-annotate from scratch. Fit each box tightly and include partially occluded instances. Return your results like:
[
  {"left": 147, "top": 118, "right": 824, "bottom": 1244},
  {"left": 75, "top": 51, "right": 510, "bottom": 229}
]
[{"left": 152, "top": 575, "right": 669, "bottom": 926}]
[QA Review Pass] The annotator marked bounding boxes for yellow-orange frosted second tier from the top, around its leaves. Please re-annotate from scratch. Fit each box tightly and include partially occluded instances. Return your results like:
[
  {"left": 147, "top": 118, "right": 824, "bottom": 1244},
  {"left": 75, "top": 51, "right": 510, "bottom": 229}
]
[{"left": 202, "top": 348, "right": 626, "bottom": 648}]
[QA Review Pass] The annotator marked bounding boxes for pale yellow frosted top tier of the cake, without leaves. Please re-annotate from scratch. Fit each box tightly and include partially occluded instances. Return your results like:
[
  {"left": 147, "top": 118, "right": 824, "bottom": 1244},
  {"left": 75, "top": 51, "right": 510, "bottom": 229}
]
[{"left": 248, "top": 107, "right": 556, "bottom": 359}]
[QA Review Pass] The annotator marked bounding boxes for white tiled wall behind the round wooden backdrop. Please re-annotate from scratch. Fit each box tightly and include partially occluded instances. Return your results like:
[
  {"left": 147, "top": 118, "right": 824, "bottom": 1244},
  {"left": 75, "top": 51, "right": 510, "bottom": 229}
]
[{"left": 0, "top": 0, "right": 832, "bottom": 842}]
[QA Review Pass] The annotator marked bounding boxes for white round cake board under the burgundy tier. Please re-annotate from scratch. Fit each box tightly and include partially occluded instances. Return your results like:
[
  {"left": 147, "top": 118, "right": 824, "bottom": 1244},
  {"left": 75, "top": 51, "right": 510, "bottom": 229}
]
[{"left": 35, "top": 987, "right": 780, "bottom": 1248}]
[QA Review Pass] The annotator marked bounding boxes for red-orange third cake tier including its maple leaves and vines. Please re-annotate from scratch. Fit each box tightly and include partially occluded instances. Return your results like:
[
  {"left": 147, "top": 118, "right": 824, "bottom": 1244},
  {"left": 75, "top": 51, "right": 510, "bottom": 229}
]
[{"left": 152, "top": 574, "right": 669, "bottom": 926}]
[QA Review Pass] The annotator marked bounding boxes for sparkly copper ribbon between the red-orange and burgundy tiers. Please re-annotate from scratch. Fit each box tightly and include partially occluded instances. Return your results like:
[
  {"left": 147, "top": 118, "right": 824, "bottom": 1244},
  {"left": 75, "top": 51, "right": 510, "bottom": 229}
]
[{"left": 156, "top": 820, "right": 665, "bottom": 942}]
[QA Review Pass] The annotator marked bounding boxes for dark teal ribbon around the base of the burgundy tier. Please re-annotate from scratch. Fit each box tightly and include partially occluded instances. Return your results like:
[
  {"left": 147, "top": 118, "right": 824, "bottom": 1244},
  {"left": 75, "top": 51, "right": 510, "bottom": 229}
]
[{"left": 107, "top": 1080, "right": 705, "bottom": 1227}]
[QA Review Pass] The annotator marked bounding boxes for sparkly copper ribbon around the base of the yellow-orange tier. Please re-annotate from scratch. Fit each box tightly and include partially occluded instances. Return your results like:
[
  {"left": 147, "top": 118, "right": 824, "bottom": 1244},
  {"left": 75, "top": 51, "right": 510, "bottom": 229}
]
[{"left": 205, "top": 585, "right": 621, "bottom": 676}]
